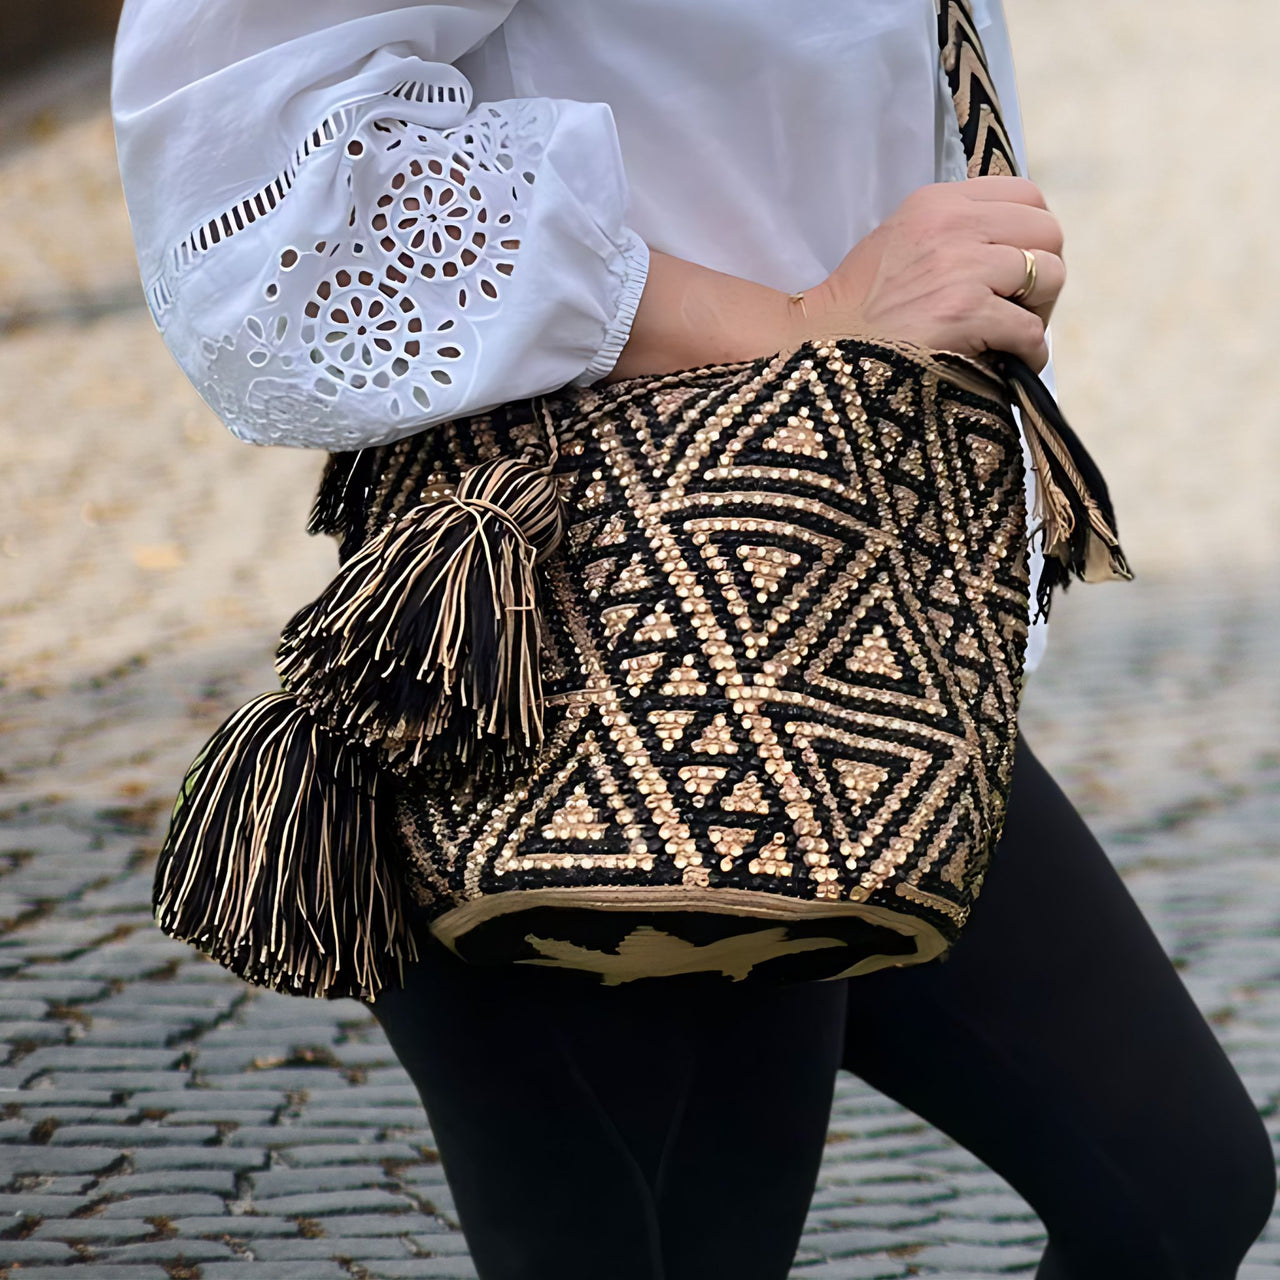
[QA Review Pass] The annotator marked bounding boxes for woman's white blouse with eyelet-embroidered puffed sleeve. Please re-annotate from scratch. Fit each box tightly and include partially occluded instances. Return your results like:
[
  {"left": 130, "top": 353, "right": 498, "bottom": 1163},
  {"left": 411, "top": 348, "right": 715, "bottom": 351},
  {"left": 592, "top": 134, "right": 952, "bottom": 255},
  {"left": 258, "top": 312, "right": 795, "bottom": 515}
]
[{"left": 113, "top": 0, "right": 1044, "bottom": 669}]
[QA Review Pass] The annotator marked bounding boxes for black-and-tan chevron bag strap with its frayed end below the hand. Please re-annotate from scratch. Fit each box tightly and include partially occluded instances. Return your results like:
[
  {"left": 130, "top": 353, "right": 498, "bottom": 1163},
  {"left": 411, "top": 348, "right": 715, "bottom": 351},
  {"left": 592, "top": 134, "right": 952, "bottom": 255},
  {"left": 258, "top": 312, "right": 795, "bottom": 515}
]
[{"left": 934, "top": 0, "right": 1133, "bottom": 617}]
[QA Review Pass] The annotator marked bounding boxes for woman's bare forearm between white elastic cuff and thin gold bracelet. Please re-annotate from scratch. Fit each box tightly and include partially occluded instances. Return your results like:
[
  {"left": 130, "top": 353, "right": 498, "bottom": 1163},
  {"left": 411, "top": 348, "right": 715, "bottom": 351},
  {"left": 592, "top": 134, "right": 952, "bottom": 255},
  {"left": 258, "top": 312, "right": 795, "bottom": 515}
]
[{"left": 605, "top": 250, "right": 804, "bottom": 383}]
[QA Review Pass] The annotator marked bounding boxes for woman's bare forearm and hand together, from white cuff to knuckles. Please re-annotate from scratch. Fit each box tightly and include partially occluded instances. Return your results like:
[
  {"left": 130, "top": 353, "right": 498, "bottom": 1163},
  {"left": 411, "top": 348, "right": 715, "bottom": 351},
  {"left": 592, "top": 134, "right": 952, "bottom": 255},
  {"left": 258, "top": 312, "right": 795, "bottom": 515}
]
[{"left": 605, "top": 178, "right": 1066, "bottom": 383}]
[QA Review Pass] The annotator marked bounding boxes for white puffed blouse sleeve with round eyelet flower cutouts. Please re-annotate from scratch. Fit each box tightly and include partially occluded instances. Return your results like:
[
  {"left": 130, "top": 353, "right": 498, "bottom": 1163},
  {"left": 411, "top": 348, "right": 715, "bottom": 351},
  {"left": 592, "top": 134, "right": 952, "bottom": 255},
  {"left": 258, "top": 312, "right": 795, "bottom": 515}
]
[{"left": 113, "top": 0, "right": 648, "bottom": 449}]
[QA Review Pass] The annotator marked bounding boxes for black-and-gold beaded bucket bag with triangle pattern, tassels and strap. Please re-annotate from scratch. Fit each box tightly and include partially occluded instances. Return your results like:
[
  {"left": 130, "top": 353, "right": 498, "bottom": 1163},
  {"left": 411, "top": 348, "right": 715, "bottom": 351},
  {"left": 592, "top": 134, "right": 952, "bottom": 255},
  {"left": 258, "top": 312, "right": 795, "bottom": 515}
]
[{"left": 155, "top": 0, "right": 1132, "bottom": 998}]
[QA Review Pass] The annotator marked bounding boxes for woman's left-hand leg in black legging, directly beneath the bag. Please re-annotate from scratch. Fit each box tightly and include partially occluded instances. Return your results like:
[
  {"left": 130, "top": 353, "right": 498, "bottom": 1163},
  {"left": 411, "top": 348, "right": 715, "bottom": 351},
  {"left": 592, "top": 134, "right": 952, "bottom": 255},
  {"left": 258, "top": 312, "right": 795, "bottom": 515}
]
[{"left": 372, "top": 945, "right": 845, "bottom": 1280}]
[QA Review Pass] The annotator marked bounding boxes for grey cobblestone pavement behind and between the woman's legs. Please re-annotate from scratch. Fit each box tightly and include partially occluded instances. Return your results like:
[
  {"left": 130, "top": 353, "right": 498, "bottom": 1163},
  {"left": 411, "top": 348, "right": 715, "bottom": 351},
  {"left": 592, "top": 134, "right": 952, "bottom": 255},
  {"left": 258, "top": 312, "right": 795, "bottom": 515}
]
[{"left": 0, "top": 580, "right": 1280, "bottom": 1280}]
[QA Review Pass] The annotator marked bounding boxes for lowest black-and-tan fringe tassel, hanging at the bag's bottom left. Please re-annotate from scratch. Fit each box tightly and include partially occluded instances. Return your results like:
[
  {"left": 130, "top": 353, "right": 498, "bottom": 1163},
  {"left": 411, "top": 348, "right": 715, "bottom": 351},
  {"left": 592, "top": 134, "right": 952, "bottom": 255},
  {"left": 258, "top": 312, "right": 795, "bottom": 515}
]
[{"left": 152, "top": 692, "right": 417, "bottom": 1000}]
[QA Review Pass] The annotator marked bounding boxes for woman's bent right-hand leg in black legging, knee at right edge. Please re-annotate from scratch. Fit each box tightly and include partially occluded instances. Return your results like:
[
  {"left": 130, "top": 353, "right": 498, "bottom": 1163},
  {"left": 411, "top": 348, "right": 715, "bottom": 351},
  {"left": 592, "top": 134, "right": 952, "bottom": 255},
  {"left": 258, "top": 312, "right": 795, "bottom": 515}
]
[{"left": 842, "top": 740, "right": 1275, "bottom": 1280}]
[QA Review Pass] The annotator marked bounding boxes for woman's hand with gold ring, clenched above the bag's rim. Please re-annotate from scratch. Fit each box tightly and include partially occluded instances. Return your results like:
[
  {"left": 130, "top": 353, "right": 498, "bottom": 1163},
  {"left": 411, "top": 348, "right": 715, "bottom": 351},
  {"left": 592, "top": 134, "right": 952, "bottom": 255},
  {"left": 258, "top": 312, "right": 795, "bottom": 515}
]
[{"left": 796, "top": 177, "right": 1066, "bottom": 371}]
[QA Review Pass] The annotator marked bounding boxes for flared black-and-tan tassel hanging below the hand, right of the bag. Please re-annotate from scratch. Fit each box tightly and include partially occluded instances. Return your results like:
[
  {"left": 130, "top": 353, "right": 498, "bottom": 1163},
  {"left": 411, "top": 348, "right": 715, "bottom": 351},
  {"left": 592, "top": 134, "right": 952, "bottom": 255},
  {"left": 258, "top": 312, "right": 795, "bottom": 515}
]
[{"left": 997, "top": 353, "right": 1133, "bottom": 620}]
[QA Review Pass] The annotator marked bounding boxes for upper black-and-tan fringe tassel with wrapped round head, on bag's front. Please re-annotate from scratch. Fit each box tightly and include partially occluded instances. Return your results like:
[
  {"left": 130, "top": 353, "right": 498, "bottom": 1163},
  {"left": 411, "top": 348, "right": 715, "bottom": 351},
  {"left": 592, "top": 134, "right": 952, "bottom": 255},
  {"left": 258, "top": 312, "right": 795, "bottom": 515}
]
[{"left": 276, "top": 458, "right": 563, "bottom": 778}]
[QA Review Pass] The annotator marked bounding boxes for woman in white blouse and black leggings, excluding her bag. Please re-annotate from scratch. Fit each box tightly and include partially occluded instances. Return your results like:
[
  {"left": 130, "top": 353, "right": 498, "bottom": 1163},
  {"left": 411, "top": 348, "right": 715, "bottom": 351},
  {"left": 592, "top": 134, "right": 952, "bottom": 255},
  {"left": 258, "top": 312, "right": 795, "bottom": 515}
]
[{"left": 114, "top": 0, "right": 1275, "bottom": 1280}]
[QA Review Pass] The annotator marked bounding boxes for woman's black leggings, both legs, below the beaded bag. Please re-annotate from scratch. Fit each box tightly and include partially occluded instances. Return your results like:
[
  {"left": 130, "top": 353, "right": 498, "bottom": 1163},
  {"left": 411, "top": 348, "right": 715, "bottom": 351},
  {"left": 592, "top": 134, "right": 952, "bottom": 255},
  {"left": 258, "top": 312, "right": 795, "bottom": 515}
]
[{"left": 374, "top": 741, "right": 1275, "bottom": 1280}]
